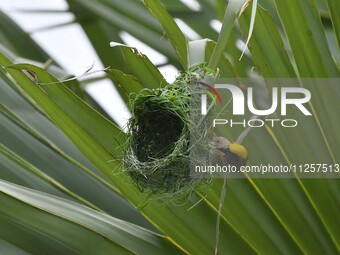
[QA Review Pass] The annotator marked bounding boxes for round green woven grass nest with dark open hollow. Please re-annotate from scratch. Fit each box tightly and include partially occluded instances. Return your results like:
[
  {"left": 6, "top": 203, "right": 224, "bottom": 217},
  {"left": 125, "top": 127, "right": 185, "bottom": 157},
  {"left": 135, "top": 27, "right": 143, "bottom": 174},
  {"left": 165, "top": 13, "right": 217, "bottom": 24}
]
[{"left": 123, "top": 70, "right": 211, "bottom": 199}]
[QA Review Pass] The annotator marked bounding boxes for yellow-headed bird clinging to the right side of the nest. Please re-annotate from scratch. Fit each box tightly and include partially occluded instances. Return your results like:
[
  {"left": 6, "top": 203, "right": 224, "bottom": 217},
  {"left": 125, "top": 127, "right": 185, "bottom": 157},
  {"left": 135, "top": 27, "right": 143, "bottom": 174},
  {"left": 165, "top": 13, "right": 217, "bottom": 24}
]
[{"left": 209, "top": 136, "right": 249, "bottom": 170}]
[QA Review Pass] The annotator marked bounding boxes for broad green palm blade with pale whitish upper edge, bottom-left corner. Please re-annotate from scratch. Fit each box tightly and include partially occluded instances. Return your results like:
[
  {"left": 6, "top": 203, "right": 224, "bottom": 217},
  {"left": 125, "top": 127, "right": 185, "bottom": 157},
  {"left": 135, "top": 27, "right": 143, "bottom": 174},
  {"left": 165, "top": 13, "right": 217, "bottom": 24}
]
[{"left": 0, "top": 181, "right": 181, "bottom": 254}]
